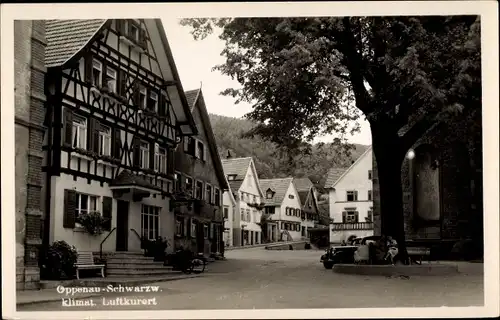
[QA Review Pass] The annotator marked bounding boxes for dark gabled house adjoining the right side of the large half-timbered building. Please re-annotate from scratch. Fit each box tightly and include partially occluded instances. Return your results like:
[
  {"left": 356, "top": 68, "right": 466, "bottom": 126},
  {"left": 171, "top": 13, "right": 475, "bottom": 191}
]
[{"left": 171, "top": 89, "right": 228, "bottom": 255}]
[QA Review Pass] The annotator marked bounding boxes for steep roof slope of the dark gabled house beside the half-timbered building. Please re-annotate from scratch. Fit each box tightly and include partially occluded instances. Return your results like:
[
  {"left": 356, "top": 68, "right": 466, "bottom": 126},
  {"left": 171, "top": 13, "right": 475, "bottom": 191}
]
[{"left": 186, "top": 89, "right": 229, "bottom": 190}]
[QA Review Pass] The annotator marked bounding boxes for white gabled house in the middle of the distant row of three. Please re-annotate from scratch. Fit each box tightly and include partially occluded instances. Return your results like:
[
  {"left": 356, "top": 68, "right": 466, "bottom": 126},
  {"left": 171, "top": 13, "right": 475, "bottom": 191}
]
[{"left": 260, "top": 178, "right": 306, "bottom": 241}]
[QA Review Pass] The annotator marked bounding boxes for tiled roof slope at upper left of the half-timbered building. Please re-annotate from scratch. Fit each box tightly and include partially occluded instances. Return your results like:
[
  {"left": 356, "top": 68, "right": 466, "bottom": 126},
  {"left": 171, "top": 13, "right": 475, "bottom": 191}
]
[{"left": 45, "top": 19, "right": 107, "bottom": 68}]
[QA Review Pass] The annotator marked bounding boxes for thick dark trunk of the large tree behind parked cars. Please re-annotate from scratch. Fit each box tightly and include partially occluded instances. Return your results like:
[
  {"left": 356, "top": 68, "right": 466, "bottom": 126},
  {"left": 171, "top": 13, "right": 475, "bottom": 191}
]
[{"left": 372, "top": 132, "right": 408, "bottom": 263}]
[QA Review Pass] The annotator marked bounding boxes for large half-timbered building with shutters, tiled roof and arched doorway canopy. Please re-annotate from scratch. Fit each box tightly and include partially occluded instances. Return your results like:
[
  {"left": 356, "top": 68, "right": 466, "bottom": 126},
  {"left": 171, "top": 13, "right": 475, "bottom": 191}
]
[{"left": 43, "top": 19, "right": 197, "bottom": 255}]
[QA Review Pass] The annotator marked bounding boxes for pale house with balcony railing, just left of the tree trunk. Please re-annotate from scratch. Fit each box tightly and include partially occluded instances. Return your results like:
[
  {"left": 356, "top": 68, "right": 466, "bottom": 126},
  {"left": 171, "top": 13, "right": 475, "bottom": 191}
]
[{"left": 325, "top": 146, "right": 373, "bottom": 244}]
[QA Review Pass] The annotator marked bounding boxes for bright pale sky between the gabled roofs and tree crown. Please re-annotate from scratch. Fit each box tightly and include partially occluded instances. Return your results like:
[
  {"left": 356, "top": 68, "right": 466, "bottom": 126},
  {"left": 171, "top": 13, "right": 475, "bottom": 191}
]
[{"left": 162, "top": 19, "right": 371, "bottom": 145}]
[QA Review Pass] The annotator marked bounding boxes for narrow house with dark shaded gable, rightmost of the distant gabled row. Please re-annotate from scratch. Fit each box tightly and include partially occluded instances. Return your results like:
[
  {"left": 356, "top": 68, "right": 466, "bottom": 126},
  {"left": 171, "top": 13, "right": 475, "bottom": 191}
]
[{"left": 293, "top": 178, "right": 319, "bottom": 238}]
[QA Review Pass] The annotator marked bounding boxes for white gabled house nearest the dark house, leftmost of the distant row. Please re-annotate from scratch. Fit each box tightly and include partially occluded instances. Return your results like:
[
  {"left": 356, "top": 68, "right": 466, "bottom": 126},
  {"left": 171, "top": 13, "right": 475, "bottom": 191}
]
[{"left": 222, "top": 157, "right": 264, "bottom": 246}]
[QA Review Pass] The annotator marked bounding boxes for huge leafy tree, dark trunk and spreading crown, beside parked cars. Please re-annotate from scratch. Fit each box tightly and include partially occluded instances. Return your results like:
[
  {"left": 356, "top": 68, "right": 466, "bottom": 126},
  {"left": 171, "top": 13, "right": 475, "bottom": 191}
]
[{"left": 181, "top": 16, "right": 481, "bottom": 255}]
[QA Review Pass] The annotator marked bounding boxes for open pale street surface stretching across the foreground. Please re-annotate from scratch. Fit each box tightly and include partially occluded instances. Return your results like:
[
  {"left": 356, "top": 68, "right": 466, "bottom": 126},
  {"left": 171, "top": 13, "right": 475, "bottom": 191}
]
[{"left": 18, "top": 248, "right": 483, "bottom": 311}]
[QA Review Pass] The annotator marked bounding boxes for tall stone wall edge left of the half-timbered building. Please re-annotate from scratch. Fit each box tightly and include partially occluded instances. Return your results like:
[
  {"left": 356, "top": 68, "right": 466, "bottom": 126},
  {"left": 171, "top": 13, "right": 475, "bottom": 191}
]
[{"left": 14, "top": 20, "right": 46, "bottom": 290}]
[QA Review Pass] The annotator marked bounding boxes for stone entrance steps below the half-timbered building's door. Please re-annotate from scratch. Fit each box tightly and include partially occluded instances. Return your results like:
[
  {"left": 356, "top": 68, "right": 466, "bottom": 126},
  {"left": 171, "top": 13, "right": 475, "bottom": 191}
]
[{"left": 106, "top": 252, "right": 179, "bottom": 277}]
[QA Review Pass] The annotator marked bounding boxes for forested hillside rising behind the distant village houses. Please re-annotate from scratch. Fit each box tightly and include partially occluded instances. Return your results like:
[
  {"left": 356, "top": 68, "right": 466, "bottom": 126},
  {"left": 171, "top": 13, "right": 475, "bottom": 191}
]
[{"left": 210, "top": 114, "right": 368, "bottom": 187}]
